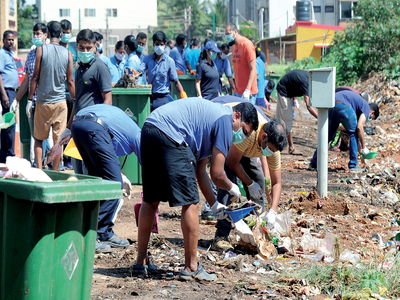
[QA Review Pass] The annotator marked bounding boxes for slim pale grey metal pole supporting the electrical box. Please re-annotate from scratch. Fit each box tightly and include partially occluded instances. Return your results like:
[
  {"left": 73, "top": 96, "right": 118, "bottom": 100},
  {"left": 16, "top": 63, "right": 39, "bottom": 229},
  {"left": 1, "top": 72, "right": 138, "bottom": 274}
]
[{"left": 317, "top": 108, "right": 329, "bottom": 198}]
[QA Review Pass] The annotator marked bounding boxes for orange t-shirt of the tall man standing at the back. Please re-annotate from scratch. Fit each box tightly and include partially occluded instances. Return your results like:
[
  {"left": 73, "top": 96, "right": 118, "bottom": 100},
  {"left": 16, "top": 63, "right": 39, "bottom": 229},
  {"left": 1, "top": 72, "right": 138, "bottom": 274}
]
[{"left": 232, "top": 37, "right": 258, "bottom": 95}]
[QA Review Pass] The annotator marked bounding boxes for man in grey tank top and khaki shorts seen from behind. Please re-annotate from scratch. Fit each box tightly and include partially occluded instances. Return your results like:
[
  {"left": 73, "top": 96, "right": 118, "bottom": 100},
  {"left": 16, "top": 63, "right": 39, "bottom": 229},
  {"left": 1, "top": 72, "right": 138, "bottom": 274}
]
[{"left": 28, "top": 21, "right": 75, "bottom": 171}]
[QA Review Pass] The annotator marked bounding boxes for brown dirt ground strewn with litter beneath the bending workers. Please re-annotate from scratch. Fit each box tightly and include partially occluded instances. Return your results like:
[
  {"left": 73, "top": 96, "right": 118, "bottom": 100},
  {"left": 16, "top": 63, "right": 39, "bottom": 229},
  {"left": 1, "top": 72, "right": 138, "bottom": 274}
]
[{"left": 91, "top": 99, "right": 400, "bottom": 299}]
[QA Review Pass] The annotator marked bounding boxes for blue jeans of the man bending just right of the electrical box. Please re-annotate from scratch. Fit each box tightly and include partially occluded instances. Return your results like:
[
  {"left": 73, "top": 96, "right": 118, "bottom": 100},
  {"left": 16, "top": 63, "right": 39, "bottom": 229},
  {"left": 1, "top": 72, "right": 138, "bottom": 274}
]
[{"left": 311, "top": 103, "right": 358, "bottom": 169}]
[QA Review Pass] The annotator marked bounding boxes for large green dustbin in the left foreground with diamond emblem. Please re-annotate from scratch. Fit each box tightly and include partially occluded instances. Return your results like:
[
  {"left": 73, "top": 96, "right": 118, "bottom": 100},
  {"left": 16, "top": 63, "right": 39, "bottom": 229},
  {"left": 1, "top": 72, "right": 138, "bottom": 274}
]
[{"left": 0, "top": 171, "right": 122, "bottom": 300}]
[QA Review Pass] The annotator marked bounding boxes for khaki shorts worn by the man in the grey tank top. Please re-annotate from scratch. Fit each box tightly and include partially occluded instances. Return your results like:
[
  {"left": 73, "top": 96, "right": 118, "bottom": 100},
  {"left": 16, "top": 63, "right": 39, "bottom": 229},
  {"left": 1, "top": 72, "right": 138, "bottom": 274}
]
[{"left": 34, "top": 101, "right": 68, "bottom": 143}]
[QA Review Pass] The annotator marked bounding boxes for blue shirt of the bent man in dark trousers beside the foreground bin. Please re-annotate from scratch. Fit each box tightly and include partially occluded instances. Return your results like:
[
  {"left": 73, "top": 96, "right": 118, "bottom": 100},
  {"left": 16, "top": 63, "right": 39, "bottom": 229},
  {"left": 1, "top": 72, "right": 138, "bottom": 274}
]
[{"left": 76, "top": 104, "right": 142, "bottom": 164}]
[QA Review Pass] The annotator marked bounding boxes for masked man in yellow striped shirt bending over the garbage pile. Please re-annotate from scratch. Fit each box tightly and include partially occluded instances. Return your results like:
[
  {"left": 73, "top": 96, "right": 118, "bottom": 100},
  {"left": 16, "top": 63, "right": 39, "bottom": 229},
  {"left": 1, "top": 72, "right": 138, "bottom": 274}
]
[{"left": 211, "top": 96, "right": 287, "bottom": 252}]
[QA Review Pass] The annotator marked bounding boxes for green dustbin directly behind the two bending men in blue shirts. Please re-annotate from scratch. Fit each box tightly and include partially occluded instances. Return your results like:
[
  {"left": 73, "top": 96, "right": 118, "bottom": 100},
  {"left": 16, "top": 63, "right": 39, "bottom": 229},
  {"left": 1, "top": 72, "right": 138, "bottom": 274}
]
[{"left": 112, "top": 88, "right": 151, "bottom": 184}]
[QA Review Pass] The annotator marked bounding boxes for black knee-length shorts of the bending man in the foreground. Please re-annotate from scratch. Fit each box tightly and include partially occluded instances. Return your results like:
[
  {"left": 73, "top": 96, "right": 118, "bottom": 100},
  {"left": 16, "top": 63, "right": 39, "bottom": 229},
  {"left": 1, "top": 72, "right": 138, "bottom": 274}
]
[{"left": 140, "top": 123, "right": 199, "bottom": 207}]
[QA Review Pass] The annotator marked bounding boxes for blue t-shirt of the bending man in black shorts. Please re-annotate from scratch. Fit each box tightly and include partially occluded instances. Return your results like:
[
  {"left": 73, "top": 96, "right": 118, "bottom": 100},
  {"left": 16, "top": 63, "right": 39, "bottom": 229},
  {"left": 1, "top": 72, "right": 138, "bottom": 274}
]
[{"left": 146, "top": 98, "right": 233, "bottom": 160}]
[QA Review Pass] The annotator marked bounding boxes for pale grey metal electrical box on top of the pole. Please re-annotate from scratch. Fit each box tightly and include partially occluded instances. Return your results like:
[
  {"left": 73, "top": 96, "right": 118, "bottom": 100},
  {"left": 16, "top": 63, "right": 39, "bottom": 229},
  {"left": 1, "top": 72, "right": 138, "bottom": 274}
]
[{"left": 308, "top": 67, "right": 336, "bottom": 108}]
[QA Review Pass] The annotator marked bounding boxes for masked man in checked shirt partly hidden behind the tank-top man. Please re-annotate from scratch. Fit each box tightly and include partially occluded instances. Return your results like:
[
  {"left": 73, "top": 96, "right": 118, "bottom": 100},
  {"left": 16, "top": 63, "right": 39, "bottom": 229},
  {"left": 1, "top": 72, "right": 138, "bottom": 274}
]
[{"left": 15, "top": 23, "right": 51, "bottom": 166}]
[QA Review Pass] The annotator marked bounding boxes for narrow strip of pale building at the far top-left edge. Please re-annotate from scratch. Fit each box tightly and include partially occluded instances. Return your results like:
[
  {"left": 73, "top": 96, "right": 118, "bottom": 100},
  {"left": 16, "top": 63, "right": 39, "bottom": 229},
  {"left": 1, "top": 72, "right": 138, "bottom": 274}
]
[{"left": 0, "top": 0, "right": 18, "bottom": 55}]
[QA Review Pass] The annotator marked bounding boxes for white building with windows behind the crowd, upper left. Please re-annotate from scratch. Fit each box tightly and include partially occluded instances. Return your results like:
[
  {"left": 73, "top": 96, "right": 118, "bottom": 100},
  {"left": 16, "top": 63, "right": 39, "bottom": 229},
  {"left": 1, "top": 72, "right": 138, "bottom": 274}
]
[{"left": 36, "top": 0, "right": 157, "bottom": 56}]
